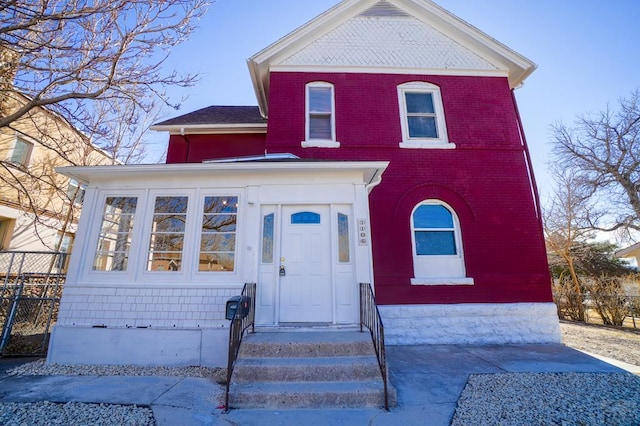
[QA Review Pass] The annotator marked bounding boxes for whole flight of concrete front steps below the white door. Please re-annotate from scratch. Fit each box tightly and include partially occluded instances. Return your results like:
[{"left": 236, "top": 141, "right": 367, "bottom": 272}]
[{"left": 229, "top": 330, "right": 396, "bottom": 409}]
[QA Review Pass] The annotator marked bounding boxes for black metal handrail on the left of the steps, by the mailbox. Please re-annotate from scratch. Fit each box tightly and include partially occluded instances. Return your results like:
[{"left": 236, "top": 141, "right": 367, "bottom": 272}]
[{"left": 224, "top": 283, "right": 256, "bottom": 411}]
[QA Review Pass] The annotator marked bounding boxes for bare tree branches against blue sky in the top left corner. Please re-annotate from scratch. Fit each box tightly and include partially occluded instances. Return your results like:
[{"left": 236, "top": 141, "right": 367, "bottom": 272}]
[{"left": 0, "top": 0, "right": 208, "bottom": 131}]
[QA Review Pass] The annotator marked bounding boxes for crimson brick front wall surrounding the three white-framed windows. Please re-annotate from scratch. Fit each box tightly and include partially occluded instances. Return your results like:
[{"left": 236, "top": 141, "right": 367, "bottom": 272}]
[{"left": 266, "top": 73, "right": 551, "bottom": 304}]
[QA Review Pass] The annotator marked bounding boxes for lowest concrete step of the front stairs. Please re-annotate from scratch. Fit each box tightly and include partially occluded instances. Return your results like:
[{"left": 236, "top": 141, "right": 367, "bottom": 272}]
[{"left": 229, "top": 380, "right": 384, "bottom": 409}]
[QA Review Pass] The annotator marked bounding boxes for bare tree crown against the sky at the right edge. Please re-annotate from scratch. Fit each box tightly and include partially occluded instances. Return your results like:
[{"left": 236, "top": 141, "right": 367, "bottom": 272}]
[{"left": 553, "top": 90, "right": 640, "bottom": 235}]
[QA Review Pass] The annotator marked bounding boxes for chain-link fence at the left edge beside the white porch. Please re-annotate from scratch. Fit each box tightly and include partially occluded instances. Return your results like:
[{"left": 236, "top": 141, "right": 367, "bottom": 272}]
[{"left": 0, "top": 251, "right": 68, "bottom": 356}]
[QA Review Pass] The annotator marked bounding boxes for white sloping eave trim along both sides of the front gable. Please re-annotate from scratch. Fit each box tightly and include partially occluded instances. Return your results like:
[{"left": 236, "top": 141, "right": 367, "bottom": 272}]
[{"left": 248, "top": 0, "right": 536, "bottom": 117}]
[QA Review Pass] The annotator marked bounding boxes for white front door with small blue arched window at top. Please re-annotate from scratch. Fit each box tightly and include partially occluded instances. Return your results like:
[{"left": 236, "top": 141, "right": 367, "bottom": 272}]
[{"left": 279, "top": 205, "right": 333, "bottom": 323}]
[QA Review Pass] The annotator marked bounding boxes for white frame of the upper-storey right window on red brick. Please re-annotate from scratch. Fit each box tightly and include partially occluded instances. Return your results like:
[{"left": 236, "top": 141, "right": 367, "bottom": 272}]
[{"left": 398, "top": 81, "right": 456, "bottom": 149}]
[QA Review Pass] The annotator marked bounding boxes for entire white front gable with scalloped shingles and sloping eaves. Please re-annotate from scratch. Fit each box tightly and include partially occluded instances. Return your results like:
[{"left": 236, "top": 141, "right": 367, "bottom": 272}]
[{"left": 247, "top": 0, "right": 536, "bottom": 117}]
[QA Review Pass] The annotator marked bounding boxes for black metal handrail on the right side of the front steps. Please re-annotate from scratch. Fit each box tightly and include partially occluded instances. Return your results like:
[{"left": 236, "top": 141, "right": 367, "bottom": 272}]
[{"left": 360, "top": 283, "right": 389, "bottom": 411}]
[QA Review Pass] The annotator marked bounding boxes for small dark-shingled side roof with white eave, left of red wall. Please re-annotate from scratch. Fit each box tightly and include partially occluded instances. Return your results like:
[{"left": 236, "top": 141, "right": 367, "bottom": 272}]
[{"left": 150, "top": 105, "right": 267, "bottom": 133}]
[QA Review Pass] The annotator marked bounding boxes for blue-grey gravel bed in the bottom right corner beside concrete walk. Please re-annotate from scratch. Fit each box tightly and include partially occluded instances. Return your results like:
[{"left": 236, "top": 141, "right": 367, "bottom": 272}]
[{"left": 451, "top": 373, "right": 640, "bottom": 426}]
